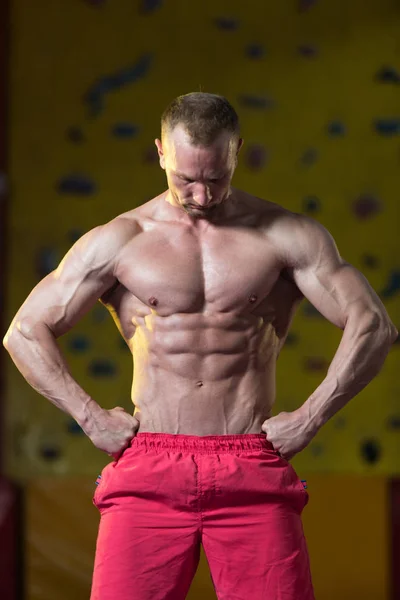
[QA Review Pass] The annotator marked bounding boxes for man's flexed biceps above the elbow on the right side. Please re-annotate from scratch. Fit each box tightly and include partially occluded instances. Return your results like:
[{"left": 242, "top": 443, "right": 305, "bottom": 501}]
[{"left": 293, "top": 263, "right": 385, "bottom": 329}]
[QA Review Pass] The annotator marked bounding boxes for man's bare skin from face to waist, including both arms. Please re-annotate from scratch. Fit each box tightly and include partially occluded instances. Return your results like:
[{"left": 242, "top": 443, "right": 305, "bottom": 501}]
[{"left": 4, "top": 112, "right": 397, "bottom": 458}]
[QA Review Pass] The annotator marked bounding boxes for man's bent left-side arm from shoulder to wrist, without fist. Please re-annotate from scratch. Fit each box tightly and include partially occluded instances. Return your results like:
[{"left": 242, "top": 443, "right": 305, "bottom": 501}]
[{"left": 3, "top": 219, "right": 132, "bottom": 436}]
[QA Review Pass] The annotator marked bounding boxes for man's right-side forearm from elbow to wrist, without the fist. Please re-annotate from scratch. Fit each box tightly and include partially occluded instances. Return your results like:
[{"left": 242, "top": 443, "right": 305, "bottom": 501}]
[{"left": 300, "top": 315, "right": 397, "bottom": 430}]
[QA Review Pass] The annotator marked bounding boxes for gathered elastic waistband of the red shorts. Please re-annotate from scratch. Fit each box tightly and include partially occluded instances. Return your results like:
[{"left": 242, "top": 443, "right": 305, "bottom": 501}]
[{"left": 130, "top": 432, "right": 274, "bottom": 454}]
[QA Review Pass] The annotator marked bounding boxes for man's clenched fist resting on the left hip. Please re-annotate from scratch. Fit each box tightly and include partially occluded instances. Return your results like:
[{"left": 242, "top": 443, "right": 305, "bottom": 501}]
[{"left": 87, "top": 406, "right": 140, "bottom": 460}]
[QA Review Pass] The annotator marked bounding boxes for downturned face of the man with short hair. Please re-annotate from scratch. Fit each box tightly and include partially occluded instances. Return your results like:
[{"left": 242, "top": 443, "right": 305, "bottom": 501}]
[{"left": 156, "top": 125, "right": 242, "bottom": 219}]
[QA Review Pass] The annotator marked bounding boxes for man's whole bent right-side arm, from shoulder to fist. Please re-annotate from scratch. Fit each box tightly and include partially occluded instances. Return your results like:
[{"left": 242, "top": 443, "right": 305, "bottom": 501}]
[{"left": 263, "top": 216, "right": 398, "bottom": 458}]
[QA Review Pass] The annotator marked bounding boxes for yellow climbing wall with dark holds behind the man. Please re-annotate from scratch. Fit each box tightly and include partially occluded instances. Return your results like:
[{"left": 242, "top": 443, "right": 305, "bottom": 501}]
[{"left": 6, "top": 0, "right": 400, "bottom": 479}]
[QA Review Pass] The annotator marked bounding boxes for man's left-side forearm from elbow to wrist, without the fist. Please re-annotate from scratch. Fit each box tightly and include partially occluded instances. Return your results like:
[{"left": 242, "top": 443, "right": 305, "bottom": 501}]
[{"left": 5, "top": 324, "right": 102, "bottom": 433}]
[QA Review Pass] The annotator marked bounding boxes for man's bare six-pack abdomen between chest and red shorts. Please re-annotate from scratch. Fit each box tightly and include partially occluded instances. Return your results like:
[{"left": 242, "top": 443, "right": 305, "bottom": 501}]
[{"left": 131, "top": 313, "right": 279, "bottom": 436}]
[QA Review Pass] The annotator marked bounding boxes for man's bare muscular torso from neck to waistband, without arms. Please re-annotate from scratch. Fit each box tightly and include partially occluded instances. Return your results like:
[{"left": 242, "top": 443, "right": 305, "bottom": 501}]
[{"left": 101, "top": 190, "right": 302, "bottom": 435}]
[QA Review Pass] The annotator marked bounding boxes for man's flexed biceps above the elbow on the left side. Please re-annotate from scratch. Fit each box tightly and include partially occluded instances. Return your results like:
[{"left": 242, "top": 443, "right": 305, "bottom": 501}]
[{"left": 10, "top": 271, "right": 114, "bottom": 337}]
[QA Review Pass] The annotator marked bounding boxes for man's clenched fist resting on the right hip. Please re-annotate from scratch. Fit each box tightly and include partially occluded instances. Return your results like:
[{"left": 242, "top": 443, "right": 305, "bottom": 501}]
[{"left": 261, "top": 409, "right": 317, "bottom": 460}]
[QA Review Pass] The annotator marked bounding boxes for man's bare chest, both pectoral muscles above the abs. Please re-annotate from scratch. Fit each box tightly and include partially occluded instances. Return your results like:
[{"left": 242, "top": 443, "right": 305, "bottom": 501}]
[{"left": 114, "top": 228, "right": 280, "bottom": 316}]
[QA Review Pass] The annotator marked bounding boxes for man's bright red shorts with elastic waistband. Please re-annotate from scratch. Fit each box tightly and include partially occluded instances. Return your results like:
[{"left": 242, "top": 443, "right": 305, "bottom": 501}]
[{"left": 91, "top": 433, "right": 314, "bottom": 600}]
